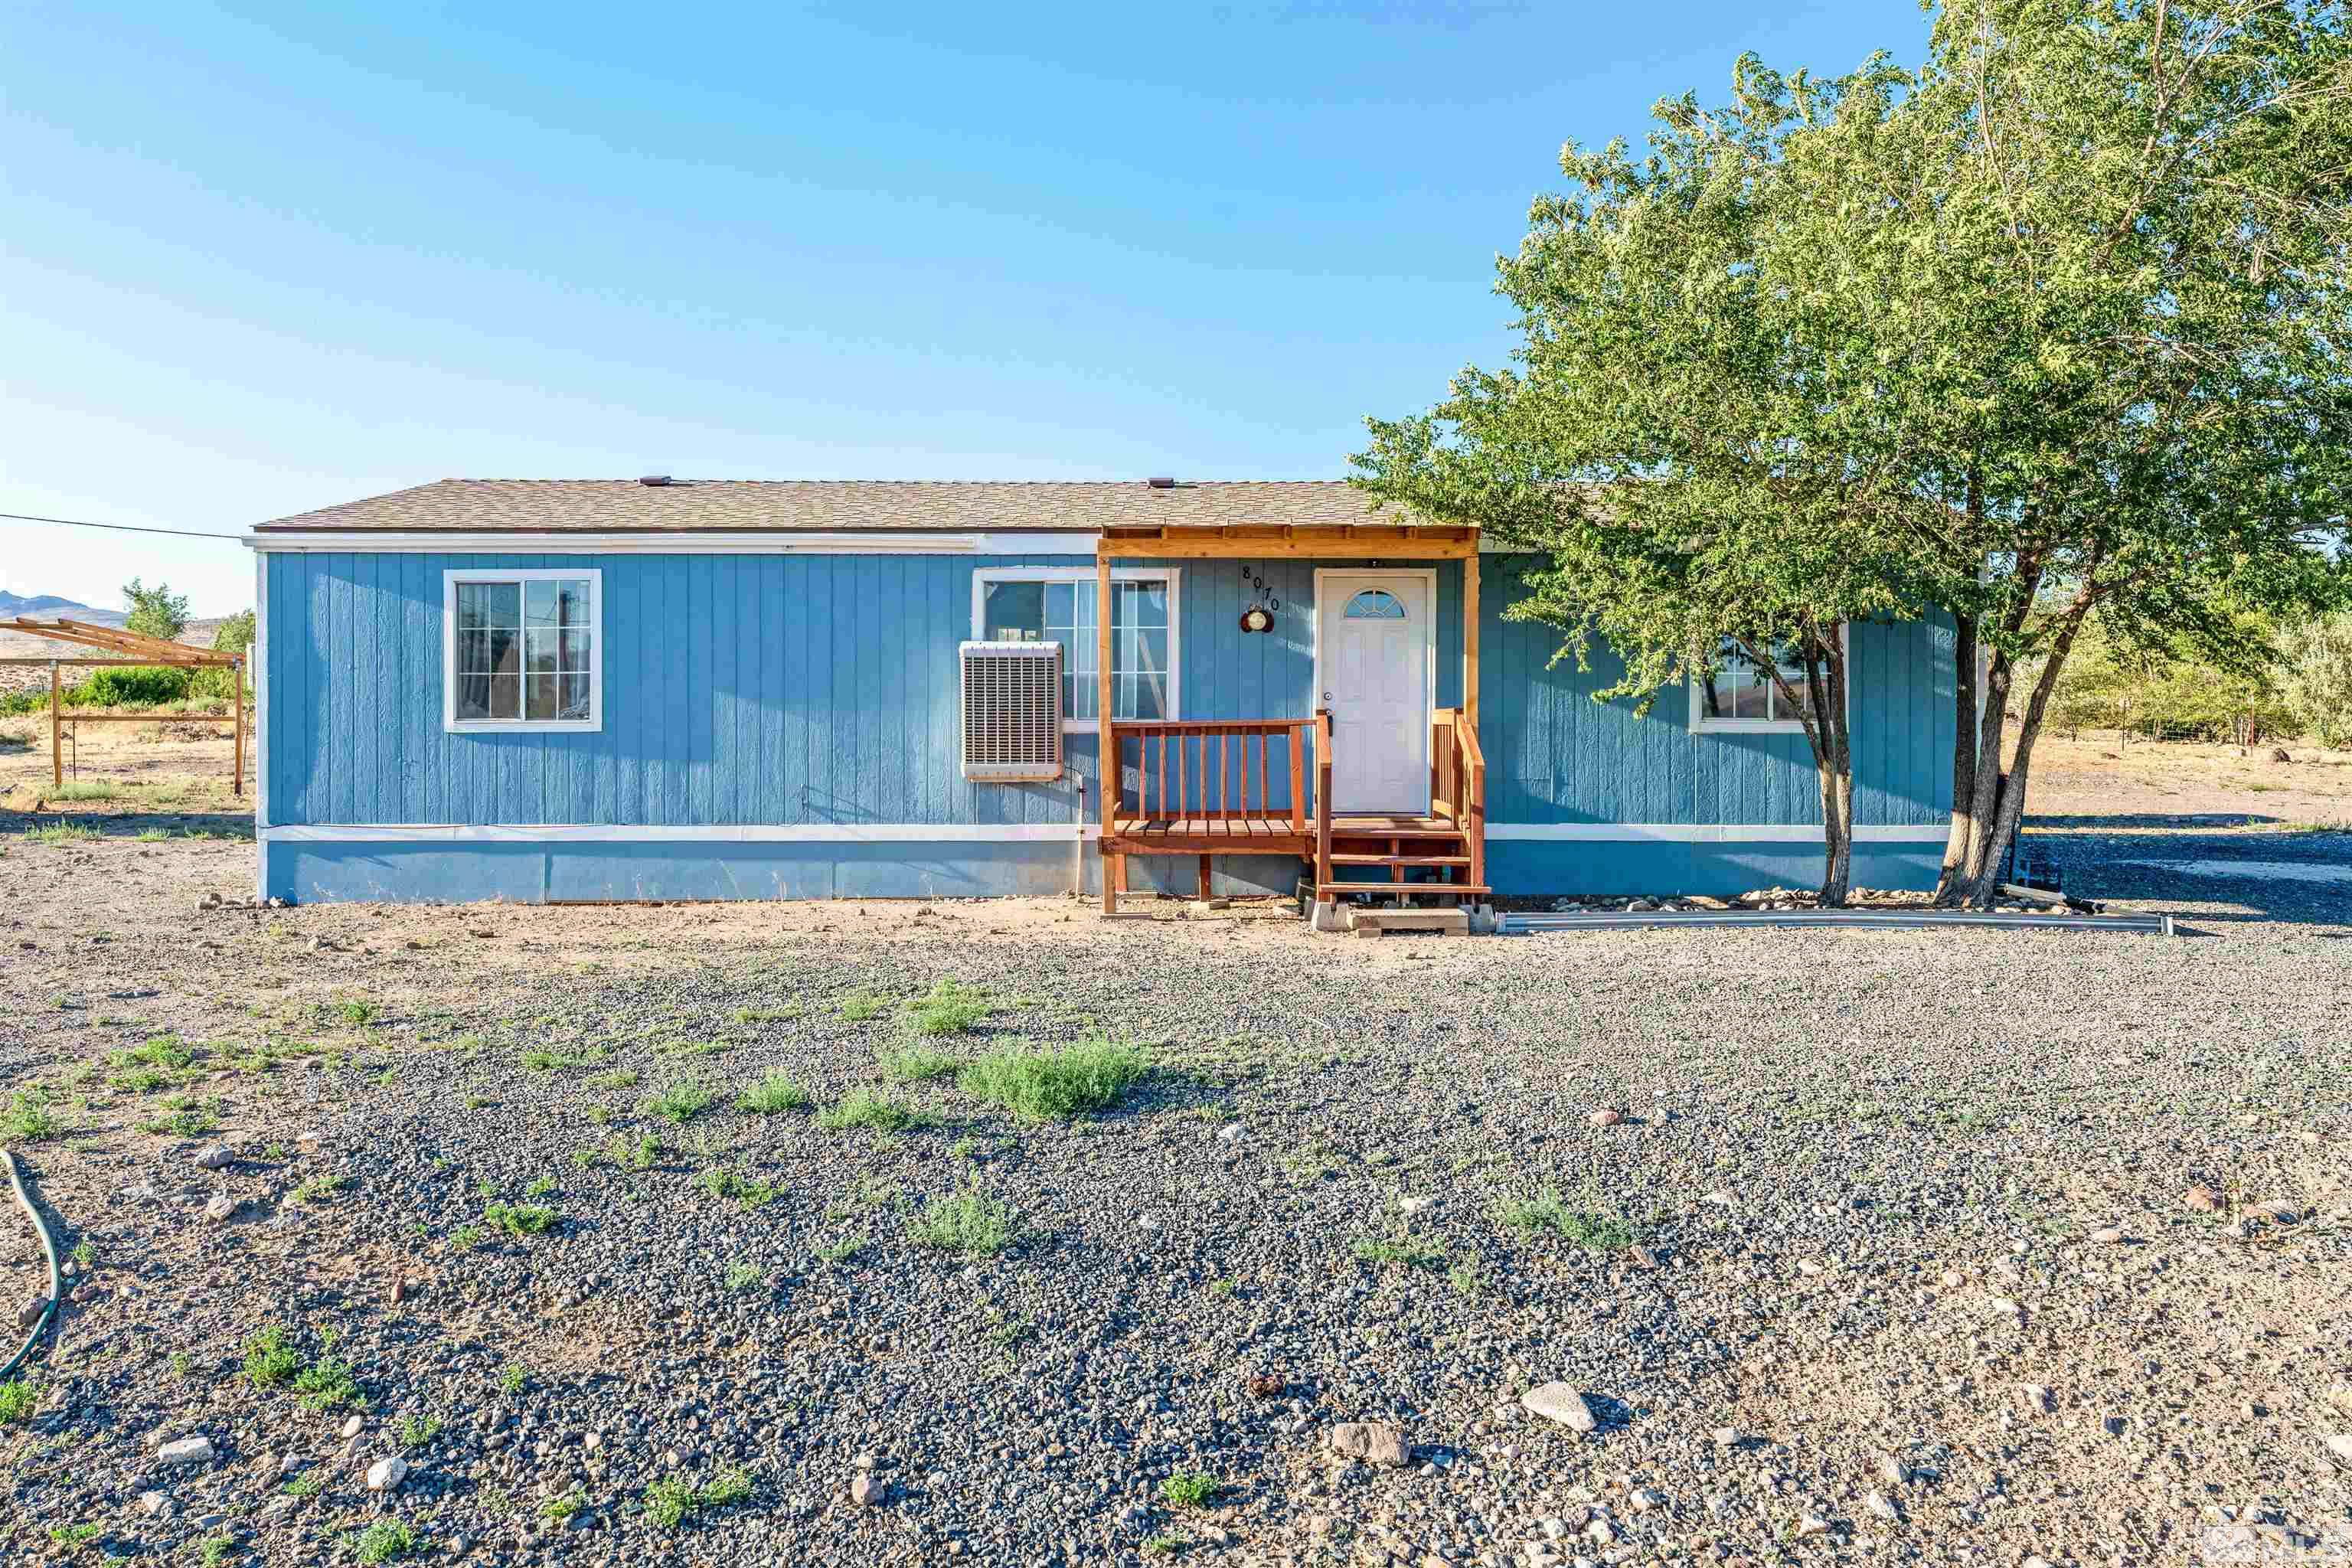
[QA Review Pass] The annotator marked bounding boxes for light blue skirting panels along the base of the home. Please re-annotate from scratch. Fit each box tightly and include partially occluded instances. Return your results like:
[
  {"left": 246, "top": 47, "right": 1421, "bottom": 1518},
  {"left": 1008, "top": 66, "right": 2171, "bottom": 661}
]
[{"left": 261, "top": 837, "right": 1942, "bottom": 903}]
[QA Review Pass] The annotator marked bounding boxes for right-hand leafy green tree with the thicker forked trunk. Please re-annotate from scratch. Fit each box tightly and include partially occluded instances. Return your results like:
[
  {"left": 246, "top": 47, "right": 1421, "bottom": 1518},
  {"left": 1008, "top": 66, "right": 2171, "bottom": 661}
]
[{"left": 1790, "top": 0, "right": 2352, "bottom": 905}]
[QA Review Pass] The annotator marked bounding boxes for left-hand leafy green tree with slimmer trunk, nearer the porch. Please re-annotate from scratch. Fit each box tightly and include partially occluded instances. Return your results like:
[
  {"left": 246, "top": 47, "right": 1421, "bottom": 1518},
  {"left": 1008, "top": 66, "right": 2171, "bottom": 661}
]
[{"left": 1354, "top": 59, "right": 1917, "bottom": 905}]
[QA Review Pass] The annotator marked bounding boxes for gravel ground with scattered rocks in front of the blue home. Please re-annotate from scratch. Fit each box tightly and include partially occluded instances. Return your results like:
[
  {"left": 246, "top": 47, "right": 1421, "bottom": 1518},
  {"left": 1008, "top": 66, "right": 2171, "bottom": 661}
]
[{"left": 0, "top": 835, "right": 2352, "bottom": 1568}]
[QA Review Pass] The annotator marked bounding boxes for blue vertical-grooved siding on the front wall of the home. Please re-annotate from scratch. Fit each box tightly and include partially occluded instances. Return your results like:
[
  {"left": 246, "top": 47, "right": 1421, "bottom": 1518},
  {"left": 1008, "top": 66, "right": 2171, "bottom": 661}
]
[{"left": 261, "top": 553, "right": 1952, "bottom": 900}]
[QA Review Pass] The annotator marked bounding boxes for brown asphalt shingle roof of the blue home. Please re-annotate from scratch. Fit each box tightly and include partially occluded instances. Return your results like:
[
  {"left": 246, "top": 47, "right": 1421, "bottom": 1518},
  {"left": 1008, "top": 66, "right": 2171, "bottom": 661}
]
[{"left": 261, "top": 479, "right": 1411, "bottom": 534}]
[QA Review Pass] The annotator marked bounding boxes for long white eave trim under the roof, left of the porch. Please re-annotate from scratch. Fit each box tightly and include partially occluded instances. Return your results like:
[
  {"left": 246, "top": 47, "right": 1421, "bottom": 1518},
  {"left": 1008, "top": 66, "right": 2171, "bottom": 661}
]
[{"left": 244, "top": 529, "right": 1093, "bottom": 562}]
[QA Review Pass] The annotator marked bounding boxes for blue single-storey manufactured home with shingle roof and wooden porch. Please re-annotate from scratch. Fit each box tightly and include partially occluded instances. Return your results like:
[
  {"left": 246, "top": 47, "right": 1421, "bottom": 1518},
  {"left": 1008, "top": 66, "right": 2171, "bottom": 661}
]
[{"left": 252, "top": 479, "right": 1957, "bottom": 907}]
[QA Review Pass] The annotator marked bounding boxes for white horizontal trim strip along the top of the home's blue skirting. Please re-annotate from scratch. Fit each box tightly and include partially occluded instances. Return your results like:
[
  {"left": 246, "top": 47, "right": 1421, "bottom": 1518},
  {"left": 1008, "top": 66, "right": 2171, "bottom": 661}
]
[{"left": 256, "top": 823, "right": 1942, "bottom": 844}]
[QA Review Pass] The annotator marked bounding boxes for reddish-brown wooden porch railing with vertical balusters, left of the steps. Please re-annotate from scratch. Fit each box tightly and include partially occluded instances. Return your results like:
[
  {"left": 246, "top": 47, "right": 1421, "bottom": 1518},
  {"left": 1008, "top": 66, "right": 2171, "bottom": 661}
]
[{"left": 1103, "top": 720, "right": 1315, "bottom": 832}]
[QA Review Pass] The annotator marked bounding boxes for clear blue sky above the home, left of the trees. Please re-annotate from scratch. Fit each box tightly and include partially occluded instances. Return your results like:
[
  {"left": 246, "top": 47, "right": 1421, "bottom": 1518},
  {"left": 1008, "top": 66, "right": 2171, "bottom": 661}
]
[{"left": 0, "top": 0, "right": 1926, "bottom": 611}]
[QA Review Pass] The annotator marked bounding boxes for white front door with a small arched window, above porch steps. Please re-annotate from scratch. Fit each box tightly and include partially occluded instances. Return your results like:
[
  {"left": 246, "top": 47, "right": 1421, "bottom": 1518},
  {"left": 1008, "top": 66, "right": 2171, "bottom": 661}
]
[{"left": 1315, "top": 571, "right": 1437, "bottom": 815}]
